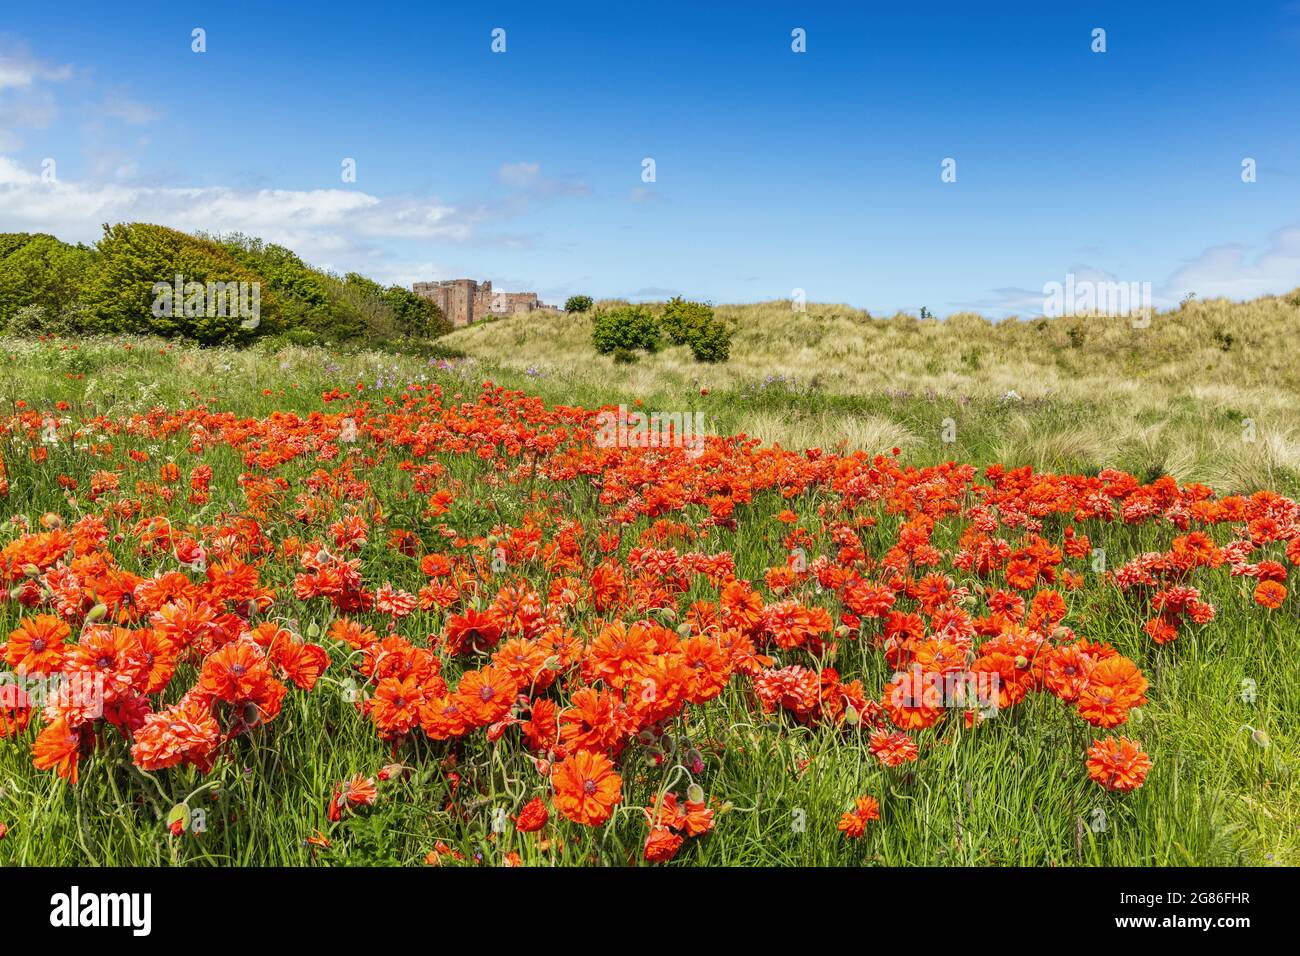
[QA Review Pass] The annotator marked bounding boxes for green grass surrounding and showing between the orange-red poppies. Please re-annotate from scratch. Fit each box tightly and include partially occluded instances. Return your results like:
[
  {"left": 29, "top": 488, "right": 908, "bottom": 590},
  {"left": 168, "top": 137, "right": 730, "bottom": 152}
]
[{"left": 0, "top": 339, "right": 1300, "bottom": 866}]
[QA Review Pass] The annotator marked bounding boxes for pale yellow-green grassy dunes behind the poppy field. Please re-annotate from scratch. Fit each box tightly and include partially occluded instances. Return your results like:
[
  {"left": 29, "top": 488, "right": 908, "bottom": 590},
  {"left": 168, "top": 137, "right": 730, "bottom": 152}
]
[{"left": 443, "top": 290, "right": 1300, "bottom": 492}]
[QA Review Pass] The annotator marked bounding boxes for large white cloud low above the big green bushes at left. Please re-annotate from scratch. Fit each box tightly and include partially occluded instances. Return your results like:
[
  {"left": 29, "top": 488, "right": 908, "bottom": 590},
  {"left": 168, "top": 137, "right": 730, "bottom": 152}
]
[{"left": 0, "top": 34, "right": 590, "bottom": 283}]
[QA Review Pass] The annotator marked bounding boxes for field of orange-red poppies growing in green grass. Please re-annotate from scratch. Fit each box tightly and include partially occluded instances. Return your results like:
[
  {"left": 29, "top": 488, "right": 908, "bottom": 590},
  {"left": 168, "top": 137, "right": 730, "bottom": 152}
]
[{"left": 0, "top": 339, "right": 1300, "bottom": 866}]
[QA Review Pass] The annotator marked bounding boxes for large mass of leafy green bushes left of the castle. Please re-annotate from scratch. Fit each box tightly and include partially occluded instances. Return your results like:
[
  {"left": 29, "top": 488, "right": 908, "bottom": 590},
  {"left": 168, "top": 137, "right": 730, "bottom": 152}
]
[{"left": 0, "top": 222, "right": 451, "bottom": 347}]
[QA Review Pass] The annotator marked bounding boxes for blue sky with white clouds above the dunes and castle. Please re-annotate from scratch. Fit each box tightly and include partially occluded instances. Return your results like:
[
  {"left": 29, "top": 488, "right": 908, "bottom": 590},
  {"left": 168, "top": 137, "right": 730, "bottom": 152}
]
[{"left": 0, "top": 0, "right": 1300, "bottom": 316}]
